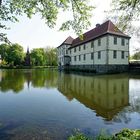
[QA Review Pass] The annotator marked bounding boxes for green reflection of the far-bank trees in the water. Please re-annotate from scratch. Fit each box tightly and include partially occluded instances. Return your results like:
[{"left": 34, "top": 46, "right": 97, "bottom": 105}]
[{"left": 0, "top": 69, "right": 57, "bottom": 93}]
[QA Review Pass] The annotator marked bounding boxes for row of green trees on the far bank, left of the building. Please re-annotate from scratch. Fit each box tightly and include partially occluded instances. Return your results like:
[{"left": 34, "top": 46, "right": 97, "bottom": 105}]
[{"left": 0, "top": 44, "right": 57, "bottom": 66}]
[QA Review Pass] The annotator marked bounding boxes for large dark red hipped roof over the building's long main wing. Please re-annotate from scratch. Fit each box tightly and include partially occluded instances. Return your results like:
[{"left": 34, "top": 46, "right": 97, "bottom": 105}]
[{"left": 72, "top": 20, "right": 130, "bottom": 47}]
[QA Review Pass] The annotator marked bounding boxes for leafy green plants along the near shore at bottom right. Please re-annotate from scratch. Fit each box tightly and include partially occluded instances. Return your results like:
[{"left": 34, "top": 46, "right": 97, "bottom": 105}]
[{"left": 68, "top": 128, "right": 140, "bottom": 140}]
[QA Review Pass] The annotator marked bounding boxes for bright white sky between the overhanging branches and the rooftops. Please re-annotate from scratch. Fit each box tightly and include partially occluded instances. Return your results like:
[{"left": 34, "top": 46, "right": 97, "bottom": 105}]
[{"left": 1, "top": 0, "right": 140, "bottom": 54}]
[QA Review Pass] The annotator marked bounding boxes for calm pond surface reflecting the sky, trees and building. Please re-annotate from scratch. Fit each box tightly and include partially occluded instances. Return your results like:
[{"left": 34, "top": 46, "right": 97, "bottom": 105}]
[{"left": 0, "top": 69, "right": 140, "bottom": 140}]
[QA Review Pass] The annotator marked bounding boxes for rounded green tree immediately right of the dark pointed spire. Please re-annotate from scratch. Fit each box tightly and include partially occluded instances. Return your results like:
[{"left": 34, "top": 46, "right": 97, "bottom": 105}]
[{"left": 30, "top": 48, "right": 46, "bottom": 66}]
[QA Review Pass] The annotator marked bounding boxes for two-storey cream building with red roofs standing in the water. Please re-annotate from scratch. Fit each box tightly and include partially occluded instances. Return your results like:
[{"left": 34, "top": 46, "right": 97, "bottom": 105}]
[{"left": 57, "top": 20, "right": 130, "bottom": 73}]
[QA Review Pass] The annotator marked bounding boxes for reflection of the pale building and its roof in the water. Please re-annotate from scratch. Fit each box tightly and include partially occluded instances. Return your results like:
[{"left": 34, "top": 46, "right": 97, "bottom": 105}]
[{"left": 58, "top": 73, "right": 129, "bottom": 121}]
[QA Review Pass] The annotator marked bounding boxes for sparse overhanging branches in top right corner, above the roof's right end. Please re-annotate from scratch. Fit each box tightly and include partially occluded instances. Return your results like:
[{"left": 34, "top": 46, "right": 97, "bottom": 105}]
[{"left": 111, "top": 0, "right": 140, "bottom": 32}]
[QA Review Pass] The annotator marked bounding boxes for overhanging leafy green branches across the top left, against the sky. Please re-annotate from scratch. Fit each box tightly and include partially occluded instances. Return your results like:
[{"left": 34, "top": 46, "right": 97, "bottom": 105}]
[{"left": 0, "top": 0, "right": 93, "bottom": 41}]
